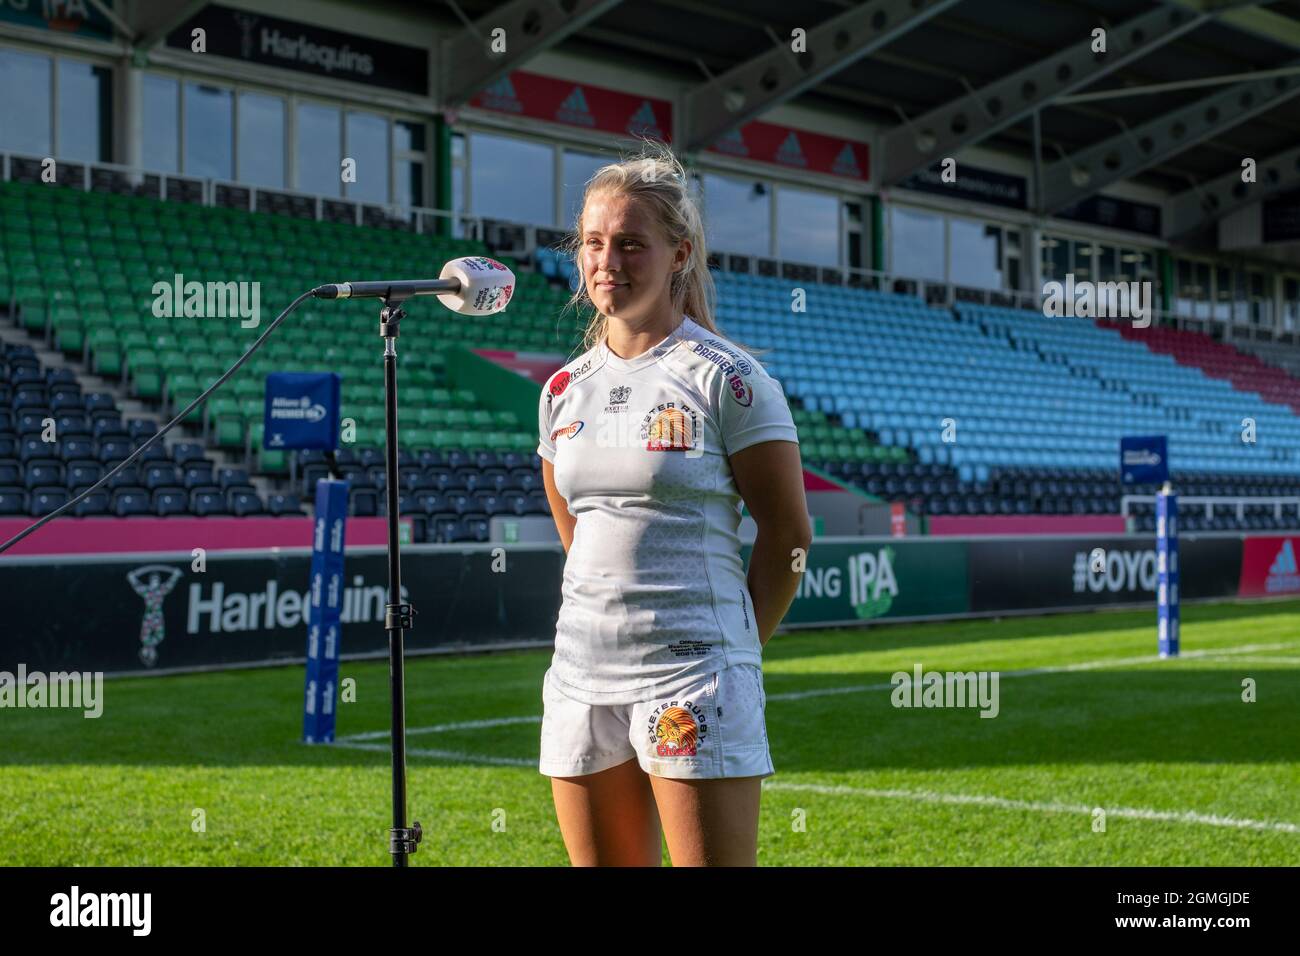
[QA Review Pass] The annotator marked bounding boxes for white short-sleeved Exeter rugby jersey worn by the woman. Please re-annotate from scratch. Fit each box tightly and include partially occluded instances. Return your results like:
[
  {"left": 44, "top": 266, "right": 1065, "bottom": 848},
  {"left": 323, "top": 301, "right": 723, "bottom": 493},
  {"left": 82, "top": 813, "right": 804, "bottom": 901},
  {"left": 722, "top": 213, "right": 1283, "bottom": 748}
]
[{"left": 537, "top": 316, "right": 798, "bottom": 704}]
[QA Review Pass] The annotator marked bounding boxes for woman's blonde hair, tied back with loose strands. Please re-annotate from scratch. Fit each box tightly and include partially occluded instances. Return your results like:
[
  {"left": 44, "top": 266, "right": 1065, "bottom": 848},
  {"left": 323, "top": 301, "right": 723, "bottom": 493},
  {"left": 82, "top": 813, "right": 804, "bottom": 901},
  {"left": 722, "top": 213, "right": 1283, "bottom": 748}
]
[{"left": 564, "top": 139, "right": 759, "bottom": 361}]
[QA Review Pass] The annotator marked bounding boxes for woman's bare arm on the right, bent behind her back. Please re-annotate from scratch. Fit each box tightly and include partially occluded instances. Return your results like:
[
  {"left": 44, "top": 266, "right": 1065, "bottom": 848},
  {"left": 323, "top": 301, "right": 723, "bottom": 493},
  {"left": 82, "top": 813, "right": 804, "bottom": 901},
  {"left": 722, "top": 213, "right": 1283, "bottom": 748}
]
[{"left": 729, "top": 441, "right": 813, "bottom": 645}]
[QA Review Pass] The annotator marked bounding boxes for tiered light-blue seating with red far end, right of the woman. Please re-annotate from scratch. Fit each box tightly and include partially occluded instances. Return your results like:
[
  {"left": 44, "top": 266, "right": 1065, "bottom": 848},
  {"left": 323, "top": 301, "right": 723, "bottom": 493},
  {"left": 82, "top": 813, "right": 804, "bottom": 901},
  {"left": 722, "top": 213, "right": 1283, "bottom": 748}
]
[{"left": 719, "top": 274, "right": 1300, "bottom": 531}]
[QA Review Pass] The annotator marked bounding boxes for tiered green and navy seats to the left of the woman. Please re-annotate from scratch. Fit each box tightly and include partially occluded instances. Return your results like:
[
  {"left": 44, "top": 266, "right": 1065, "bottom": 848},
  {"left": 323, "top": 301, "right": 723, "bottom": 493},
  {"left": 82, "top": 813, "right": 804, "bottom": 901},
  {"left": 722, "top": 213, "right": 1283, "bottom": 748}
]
[{"left": 0, "top": 182, "right": 572, "bottom": 541}]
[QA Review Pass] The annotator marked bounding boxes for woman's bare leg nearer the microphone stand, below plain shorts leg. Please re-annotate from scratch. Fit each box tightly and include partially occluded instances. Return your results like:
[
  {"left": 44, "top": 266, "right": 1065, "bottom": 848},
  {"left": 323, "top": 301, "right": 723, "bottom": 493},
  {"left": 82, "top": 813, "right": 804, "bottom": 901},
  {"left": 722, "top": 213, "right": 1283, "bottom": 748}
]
[{"left": 551, "top": 757, "right": 663, "bottom": 866}]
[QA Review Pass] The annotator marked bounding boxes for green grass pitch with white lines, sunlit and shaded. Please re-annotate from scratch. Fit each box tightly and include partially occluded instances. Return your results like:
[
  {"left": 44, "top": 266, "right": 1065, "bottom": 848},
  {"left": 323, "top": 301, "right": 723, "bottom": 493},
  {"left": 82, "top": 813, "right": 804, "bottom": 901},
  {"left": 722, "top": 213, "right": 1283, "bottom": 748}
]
[{"left": 0, "top": 601, "right": 1300, "bottom": 866}]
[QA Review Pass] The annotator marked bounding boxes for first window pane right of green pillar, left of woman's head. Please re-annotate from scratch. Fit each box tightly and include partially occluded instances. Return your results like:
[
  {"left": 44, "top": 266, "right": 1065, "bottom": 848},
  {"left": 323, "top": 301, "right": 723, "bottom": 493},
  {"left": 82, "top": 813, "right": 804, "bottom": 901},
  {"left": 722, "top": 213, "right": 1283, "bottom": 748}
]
[{"left": 469, "top": 133, "right": 555, "bottom": 226}]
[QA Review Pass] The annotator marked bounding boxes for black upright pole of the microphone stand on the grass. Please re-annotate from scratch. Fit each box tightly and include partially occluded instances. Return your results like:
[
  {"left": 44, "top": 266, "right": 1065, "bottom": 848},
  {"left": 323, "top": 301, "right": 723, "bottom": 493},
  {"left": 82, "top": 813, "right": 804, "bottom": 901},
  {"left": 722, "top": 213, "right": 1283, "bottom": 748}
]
[{"left": 380, "top": 291, "right": 424, "bottom": 866}]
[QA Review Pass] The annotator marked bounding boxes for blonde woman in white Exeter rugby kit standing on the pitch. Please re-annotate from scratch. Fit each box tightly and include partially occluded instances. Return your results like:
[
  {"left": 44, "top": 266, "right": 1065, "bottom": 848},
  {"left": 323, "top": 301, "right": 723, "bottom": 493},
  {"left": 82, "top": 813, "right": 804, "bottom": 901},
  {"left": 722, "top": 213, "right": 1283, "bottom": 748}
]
[{"left": 537, "top": 146, "right": 811, "bottom": 866}]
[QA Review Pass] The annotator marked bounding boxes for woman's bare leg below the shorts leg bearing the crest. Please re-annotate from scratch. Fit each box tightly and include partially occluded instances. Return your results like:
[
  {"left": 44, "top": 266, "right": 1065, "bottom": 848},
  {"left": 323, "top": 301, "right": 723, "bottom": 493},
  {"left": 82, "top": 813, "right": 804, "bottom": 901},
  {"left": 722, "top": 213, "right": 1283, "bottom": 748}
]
[{"left": 650, "top": 777, "right": 763, "bottom": 866}]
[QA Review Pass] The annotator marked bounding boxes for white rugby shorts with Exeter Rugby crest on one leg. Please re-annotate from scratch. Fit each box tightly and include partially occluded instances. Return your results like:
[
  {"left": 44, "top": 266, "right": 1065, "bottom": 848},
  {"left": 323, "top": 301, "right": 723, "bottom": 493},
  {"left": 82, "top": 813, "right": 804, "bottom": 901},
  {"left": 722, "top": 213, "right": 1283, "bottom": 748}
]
[{"left": 538, "top": 663, "right": 776, "bottom": 780}]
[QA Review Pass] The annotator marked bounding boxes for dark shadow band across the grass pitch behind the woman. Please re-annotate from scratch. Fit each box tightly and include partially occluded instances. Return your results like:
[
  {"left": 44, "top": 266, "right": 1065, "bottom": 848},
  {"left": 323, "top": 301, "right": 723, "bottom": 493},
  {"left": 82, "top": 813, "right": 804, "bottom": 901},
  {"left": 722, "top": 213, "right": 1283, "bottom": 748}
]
[{"left": 0, "top": 659, "right": 1300, "bottom": 790}]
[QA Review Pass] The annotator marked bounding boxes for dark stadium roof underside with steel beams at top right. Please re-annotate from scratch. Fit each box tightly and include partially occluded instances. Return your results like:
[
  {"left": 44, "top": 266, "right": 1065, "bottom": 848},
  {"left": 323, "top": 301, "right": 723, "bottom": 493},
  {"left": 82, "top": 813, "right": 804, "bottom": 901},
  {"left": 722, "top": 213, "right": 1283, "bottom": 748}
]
[{"left": 423, "top": 0, "right": 1300, "bottom": 233}]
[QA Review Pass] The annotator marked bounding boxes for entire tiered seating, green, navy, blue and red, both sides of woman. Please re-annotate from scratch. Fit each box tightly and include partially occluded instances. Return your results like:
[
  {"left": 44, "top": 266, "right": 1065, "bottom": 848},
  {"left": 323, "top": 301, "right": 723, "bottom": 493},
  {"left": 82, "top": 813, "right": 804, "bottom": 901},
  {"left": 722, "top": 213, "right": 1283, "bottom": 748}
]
[{"left": 0, "top": 182, "right": 1300, "bottom": 541}]
